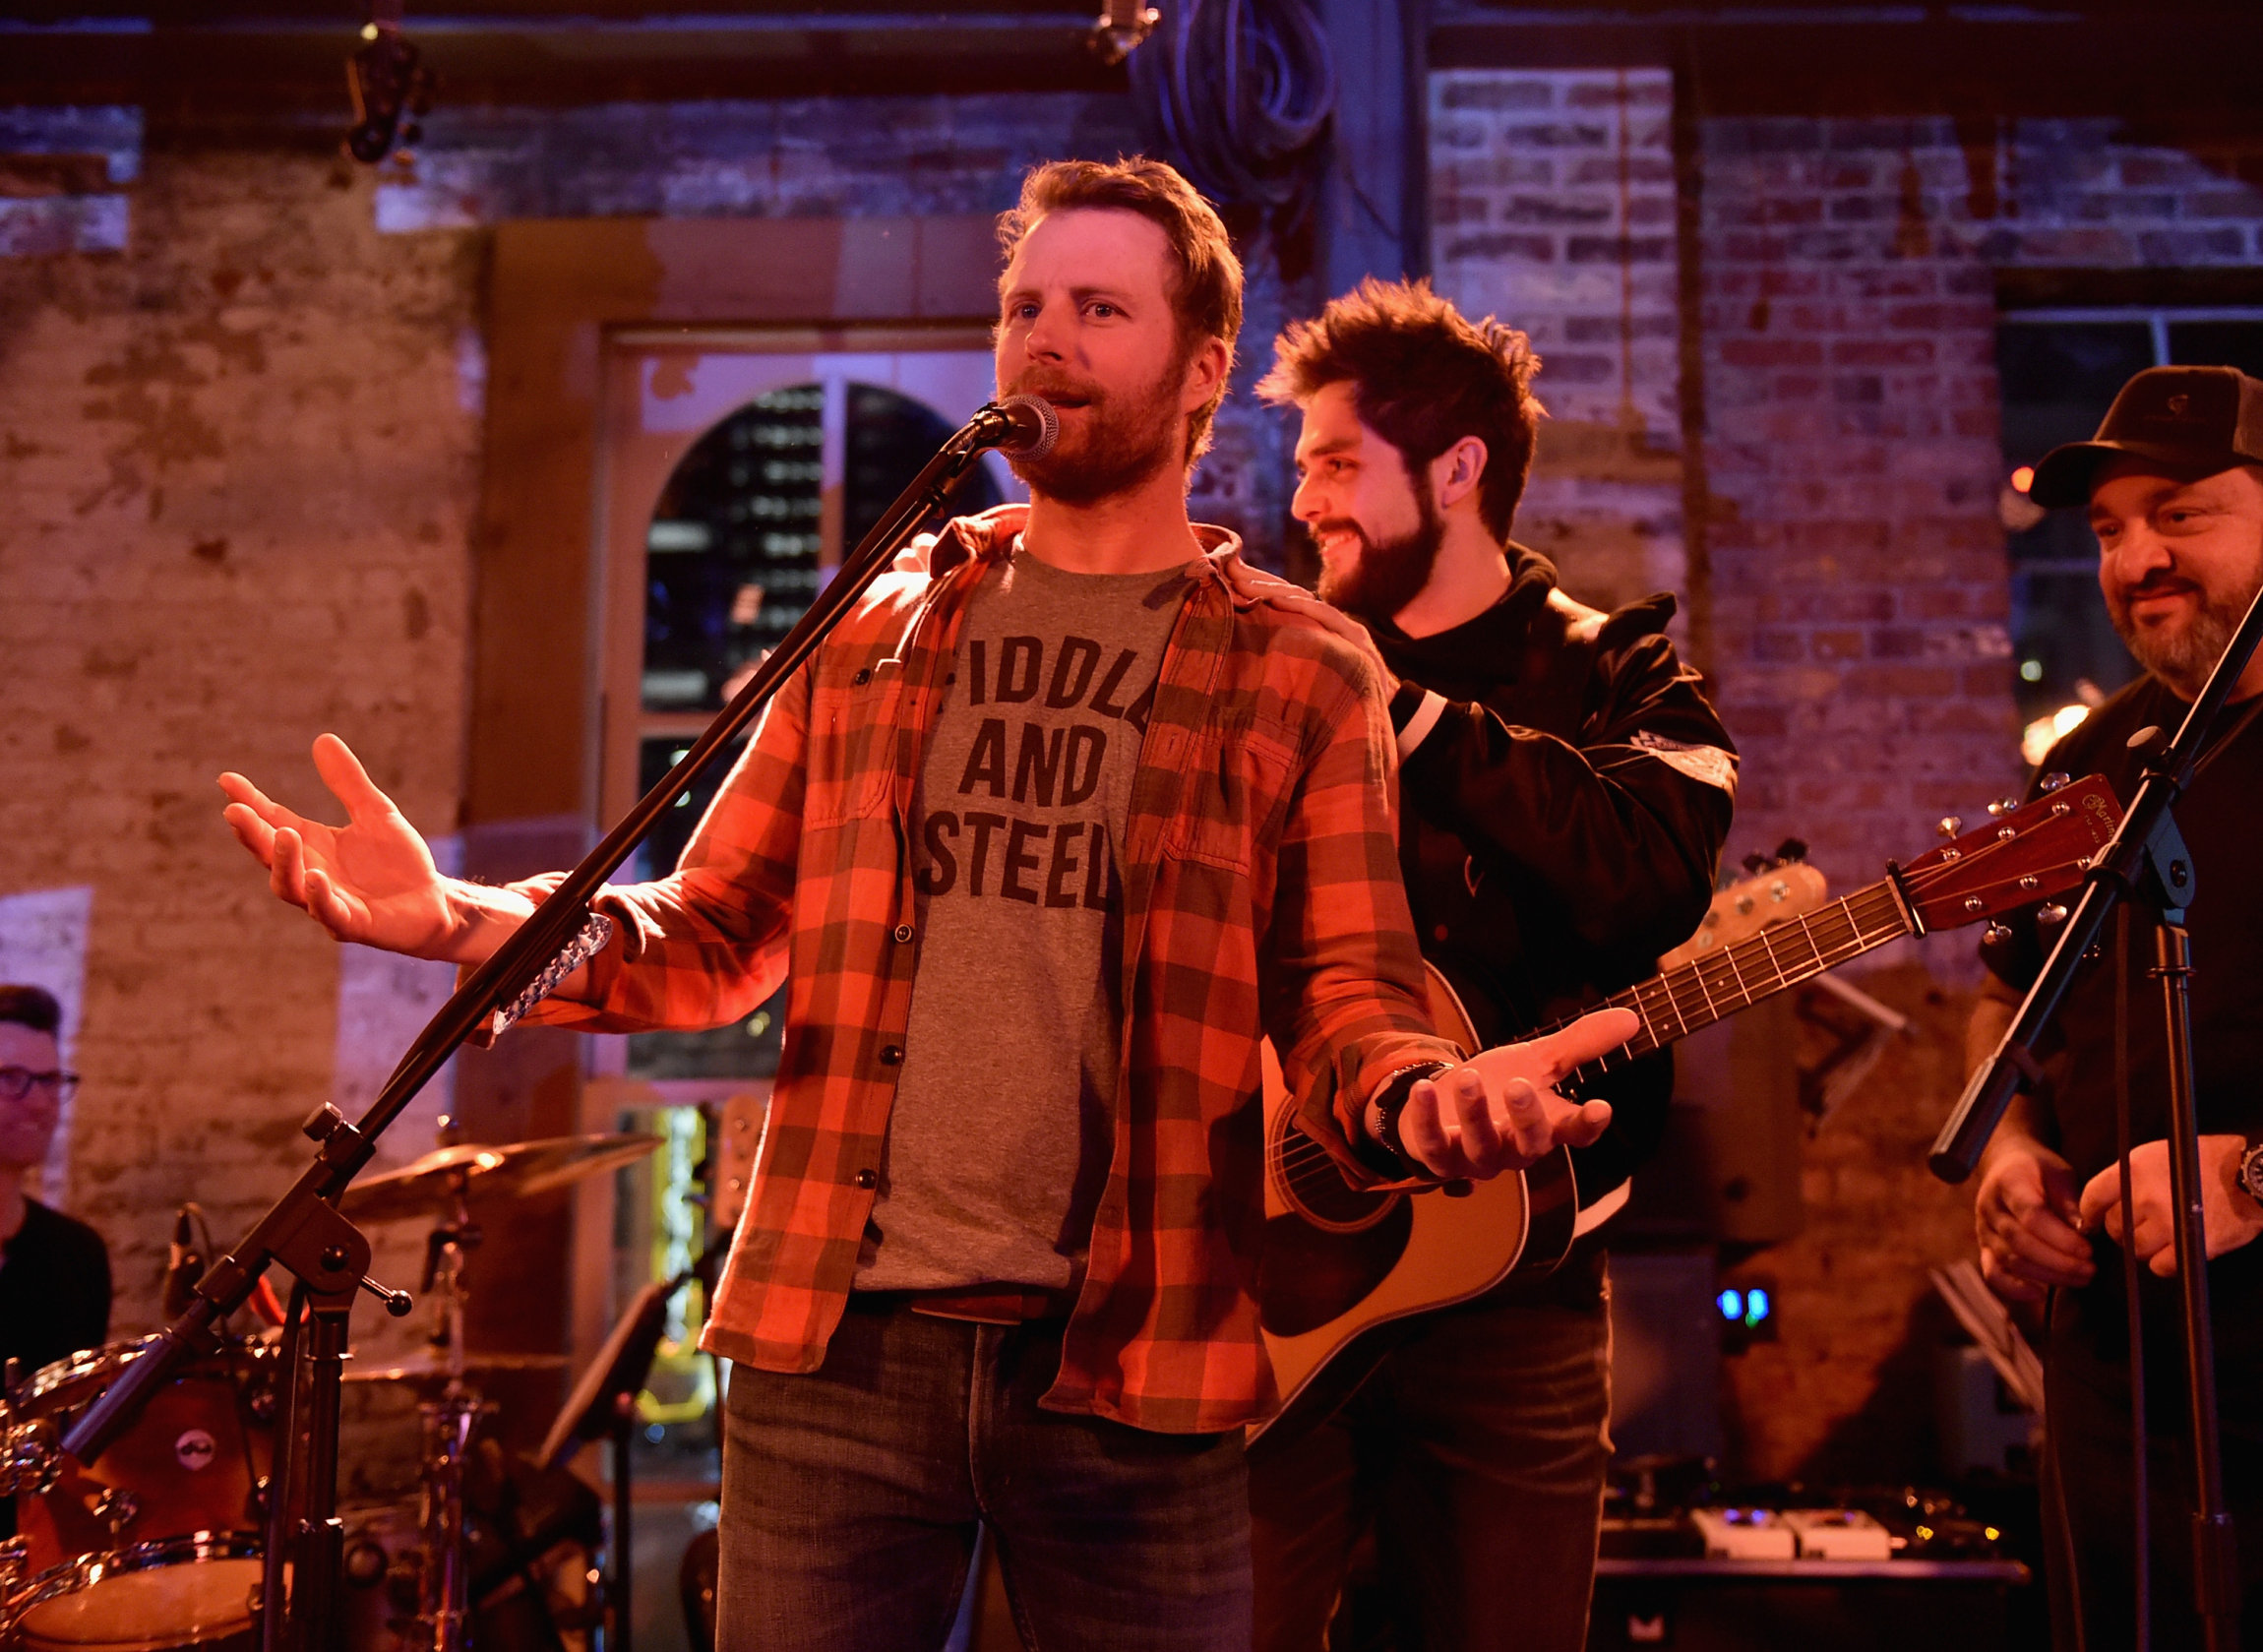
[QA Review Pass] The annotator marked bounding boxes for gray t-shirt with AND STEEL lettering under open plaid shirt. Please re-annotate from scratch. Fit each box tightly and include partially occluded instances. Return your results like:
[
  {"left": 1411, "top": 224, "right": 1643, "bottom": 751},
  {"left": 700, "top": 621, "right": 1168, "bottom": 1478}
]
[{"left": 855, "top": 552, "right": 1189, "bottom": 1290}]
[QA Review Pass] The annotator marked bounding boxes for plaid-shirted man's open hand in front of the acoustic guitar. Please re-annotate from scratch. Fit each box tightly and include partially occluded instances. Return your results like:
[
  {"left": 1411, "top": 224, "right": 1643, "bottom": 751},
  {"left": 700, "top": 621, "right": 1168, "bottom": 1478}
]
[{"left": 1398, "top": 1010, "right": 1643, "bottom": 1182}]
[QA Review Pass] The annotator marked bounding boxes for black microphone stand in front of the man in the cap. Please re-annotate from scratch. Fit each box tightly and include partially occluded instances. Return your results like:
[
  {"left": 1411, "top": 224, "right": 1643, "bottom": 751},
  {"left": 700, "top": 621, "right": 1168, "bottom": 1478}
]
[{"left": 1928, "top": 570, "right": 2263, "bottom": 1652}]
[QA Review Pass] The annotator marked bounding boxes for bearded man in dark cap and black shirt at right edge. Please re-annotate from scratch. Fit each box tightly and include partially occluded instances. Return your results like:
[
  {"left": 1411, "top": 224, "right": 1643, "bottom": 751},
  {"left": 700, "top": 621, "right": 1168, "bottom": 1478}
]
[{"left": 1967, "top": 367, "right": 2263, "bottom": 1647}]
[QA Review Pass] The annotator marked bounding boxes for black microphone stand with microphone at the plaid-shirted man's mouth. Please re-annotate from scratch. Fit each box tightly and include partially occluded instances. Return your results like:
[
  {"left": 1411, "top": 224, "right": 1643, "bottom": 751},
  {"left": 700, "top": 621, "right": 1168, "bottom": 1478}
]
[{"left": 61, "top": 397, "right": 1036, "bottom": 1652}]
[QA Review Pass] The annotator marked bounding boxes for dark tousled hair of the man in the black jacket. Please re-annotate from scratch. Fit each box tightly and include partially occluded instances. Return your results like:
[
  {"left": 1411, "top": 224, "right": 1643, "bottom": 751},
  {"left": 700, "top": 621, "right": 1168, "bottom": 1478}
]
[{"left": 1258, "top": 276, "right": 1548, "bottom": 538}]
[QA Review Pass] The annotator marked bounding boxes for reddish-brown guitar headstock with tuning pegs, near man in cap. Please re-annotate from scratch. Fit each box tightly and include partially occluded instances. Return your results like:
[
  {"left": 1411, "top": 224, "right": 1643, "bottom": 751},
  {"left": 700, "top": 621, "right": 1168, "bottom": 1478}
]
[{"left": 1899, "top": 774, "right": 2120, "bottom": 930}]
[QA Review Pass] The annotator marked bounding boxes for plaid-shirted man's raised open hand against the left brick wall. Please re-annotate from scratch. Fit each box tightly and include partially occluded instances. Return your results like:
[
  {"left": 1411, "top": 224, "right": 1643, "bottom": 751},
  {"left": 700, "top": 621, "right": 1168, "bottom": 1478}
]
[{"left": 219, "top": 733, "right": 466, "bottom": 962}]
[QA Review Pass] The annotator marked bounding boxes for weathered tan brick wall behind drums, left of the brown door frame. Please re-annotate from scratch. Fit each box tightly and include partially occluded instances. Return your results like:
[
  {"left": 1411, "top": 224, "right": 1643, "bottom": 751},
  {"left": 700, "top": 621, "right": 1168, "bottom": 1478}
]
[{"left": 0, "top": 152, "right": 477, "bottom": 1333}]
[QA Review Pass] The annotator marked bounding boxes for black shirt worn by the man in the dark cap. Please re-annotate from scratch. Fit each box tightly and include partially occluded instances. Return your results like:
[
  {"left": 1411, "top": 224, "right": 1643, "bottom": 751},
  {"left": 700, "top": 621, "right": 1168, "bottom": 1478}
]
[{"left": 1983, "top": 677, "right": 2263, "bottom": 1439}]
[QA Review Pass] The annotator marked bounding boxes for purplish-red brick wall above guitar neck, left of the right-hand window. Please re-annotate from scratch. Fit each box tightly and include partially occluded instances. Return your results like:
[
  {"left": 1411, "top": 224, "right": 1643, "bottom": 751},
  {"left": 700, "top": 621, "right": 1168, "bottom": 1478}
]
[{"left": 1702, "top": 120, "right": 2263, "bottom": 895}]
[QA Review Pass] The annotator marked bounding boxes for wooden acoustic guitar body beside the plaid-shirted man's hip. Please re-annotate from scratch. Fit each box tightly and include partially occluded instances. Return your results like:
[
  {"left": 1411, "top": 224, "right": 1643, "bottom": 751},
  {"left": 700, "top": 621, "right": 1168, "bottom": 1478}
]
[{"left": 1250, "top": 966, "right": 1577, "bottom": 1443}]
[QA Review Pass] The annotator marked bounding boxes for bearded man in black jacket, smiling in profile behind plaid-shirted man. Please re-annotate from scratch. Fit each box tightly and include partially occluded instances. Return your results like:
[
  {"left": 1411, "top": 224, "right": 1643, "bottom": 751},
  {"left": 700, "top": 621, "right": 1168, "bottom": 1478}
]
[{"left": 1252, "top": 280, "right": 1736, "bottom": 1652}]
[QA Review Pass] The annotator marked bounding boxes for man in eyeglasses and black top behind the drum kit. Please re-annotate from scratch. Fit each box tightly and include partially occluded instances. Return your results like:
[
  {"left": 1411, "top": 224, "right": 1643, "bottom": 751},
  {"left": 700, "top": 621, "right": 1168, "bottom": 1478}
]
[{"left": 0, "top": 987, "right": 111, "bottom": 1376}]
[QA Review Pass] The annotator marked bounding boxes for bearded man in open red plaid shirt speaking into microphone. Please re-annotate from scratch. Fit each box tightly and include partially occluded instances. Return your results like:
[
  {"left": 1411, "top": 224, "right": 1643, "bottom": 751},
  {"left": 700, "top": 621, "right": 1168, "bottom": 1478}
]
[{"left": 221, "top": 160, "right": 1634, "bottom": 1652}]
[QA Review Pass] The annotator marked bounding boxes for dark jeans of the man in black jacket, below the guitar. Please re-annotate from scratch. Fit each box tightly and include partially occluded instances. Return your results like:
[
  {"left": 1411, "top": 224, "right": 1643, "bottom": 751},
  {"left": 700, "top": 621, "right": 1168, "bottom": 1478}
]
[{"left": 1250, "top": 1252, "right": 1612, "bottom": 1652}]
